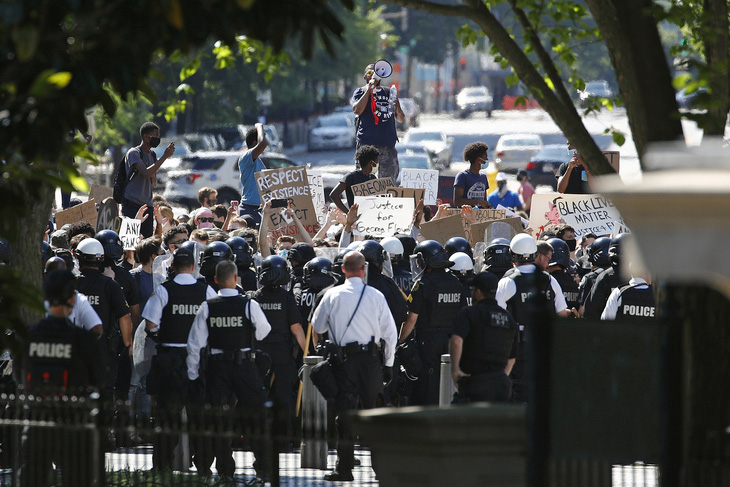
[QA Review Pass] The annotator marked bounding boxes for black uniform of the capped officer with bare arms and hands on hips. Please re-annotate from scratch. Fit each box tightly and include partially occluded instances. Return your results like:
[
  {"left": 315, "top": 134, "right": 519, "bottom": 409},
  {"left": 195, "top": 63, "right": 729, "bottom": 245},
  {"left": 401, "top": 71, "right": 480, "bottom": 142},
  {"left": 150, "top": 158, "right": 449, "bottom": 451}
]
[{"left": 452, "top": 299, "right": 518, "bottom": 403}]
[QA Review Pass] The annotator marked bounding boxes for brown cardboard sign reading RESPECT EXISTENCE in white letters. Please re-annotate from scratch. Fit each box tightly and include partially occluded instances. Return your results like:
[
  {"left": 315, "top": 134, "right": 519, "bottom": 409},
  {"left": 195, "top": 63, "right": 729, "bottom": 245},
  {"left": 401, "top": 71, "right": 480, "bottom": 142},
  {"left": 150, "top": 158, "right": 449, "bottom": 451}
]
[{"left": 255, "top": 166, "right": 320, "bottom": 239}]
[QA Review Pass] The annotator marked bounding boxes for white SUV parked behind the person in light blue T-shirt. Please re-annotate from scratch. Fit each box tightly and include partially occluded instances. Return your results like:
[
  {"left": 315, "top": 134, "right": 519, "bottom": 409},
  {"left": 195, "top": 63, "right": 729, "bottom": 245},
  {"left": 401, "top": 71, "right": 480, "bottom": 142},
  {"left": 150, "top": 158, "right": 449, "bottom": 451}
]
[{"left": 163, "top": 151, "right": 297, "bottom": 209}]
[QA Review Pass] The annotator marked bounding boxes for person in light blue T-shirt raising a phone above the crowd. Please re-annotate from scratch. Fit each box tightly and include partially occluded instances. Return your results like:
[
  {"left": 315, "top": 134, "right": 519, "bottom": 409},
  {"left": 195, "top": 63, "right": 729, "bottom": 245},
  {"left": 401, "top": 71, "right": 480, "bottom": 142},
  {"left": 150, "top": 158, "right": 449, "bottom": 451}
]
[{"left": 238, "top": 123, "right": 269, "bottom": 227}]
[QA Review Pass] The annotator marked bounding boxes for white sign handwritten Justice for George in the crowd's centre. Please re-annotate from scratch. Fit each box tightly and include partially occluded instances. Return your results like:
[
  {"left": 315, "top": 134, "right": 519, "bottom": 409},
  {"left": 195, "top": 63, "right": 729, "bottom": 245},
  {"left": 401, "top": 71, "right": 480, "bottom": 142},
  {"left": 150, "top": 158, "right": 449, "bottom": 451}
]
[{"left": 354, "top": 196, "right": 415, "bottom": 237}]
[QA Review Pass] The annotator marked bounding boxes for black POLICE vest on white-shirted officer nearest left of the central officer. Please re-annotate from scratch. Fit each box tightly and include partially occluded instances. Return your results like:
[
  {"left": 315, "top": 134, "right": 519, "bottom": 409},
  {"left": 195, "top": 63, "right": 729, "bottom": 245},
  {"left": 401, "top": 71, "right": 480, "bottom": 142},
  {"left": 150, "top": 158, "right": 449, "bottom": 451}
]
[{"left": 206, "top": 294, "right": 254, "bottom": 351}]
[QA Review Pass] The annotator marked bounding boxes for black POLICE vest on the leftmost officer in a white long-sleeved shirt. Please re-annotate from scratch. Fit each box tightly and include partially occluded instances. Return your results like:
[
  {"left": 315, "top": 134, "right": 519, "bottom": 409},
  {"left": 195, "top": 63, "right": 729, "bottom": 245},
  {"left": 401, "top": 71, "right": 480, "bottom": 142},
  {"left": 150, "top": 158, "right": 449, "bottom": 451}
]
[{"left": 159, "top": 281, "right": 208, "bottom": 343}]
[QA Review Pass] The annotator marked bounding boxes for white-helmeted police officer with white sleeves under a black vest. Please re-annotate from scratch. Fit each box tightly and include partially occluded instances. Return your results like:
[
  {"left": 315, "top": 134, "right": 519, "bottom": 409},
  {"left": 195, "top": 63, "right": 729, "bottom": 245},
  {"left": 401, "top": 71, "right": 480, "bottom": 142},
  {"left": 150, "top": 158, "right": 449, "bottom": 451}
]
[{"left": 496, "top": 233, "right": 568, "bottom": 402}]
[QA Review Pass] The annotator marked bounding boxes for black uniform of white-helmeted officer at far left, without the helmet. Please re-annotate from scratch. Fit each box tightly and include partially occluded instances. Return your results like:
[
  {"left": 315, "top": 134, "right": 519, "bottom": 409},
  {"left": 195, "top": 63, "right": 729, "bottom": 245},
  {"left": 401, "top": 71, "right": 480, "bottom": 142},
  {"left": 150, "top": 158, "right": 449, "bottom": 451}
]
[{"left": 78, "top": 268, "right": 130, "bottom": 399}]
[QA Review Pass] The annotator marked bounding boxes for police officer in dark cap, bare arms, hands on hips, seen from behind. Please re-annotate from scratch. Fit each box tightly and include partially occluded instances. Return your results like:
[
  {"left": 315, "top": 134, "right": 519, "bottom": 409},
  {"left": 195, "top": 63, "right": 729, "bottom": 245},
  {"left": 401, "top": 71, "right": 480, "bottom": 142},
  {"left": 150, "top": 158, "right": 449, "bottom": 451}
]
[{"left": 449, "top": 272, "right": 518, "bottom": 403}]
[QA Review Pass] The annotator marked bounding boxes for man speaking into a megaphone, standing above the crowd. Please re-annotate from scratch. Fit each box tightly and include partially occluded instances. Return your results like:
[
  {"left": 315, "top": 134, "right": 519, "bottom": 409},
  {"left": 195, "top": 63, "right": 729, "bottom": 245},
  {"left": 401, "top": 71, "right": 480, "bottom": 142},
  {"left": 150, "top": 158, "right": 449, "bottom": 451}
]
[{"left": 352, "top": 59, "right": 405, "bottom": 181}]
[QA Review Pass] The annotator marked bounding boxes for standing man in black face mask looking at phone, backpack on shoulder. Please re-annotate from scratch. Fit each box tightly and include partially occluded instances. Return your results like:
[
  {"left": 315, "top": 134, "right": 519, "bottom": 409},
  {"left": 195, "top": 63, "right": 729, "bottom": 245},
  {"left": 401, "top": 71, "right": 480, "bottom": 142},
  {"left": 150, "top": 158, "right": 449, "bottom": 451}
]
[{"left": 122, "top": 122, "right": 175, "bottom": 238}]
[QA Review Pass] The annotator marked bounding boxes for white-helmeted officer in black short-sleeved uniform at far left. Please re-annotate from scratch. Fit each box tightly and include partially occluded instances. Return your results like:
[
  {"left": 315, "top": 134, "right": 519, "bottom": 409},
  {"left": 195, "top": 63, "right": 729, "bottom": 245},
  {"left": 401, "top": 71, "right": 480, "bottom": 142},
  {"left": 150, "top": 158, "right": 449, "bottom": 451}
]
[{"left": 75, "top": 238, "right": 132, "bottom": 400}]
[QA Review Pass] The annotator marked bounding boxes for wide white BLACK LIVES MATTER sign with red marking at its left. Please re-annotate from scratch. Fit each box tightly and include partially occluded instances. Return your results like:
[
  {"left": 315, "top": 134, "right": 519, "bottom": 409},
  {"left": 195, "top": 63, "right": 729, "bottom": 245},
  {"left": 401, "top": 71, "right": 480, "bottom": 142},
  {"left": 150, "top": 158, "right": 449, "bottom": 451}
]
[{"left": 529, "top": 193, "right": 626, "bottom": 238}]
